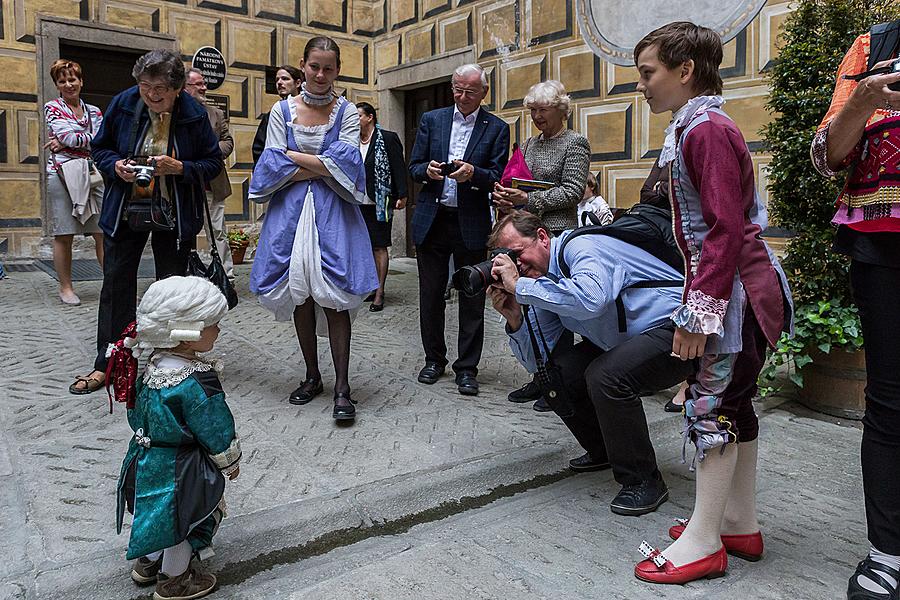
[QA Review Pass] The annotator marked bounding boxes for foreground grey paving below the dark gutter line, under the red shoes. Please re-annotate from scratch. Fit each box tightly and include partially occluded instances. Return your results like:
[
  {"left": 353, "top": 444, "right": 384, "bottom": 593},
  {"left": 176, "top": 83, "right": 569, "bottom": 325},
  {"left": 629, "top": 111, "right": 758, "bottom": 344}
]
[{"left": 211, "top": 410, "right": 867, "bottom": 600}]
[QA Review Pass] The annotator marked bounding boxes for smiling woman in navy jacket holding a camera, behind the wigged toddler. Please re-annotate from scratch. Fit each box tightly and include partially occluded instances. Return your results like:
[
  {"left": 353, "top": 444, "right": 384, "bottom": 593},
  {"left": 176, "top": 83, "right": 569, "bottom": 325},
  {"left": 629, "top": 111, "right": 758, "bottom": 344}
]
[{"left": 69, "top": 50, "right": 222, "bottom": 394}]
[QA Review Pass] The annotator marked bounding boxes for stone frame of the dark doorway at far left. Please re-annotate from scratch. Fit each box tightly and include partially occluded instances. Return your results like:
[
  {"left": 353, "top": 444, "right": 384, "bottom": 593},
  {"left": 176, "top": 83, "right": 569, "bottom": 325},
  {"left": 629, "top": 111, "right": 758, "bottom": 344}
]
[{"left": 35, "top": 14, "right": 180, "bottom": 237}]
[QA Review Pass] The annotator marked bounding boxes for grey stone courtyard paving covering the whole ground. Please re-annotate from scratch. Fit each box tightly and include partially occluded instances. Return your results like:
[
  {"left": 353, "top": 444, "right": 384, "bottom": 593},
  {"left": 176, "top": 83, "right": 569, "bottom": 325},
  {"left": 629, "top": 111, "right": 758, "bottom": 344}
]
[{"left": 0, "top": 259, "right": 865, "bottom": 599}]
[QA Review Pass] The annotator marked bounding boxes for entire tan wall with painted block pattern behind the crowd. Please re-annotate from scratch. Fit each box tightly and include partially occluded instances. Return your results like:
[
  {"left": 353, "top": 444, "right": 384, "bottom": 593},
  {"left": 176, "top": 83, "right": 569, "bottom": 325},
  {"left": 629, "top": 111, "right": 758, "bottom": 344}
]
[{"left": 0, "top": 0, "right": 790, "bottom": 256}]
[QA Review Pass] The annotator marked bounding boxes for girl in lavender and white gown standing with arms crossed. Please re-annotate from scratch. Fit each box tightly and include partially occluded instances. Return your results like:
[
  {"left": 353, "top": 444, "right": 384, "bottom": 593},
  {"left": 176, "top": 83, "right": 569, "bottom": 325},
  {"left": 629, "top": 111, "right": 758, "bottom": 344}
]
[{"left": 250, "top": 36, "right": 378, "bottom": 421}]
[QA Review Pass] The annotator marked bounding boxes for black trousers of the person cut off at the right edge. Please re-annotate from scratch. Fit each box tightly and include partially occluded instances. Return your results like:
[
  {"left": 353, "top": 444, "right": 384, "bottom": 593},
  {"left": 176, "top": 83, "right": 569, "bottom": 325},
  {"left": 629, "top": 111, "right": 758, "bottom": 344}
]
[{"left": 850, "top": 260, "right": 900, "bottom": 555}]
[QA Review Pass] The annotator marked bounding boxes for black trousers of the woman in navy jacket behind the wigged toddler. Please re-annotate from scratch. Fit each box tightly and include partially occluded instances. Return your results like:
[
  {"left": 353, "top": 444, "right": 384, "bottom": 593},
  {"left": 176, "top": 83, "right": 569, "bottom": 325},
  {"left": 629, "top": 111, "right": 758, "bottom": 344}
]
[{"left": 94, "top": 221, "right": 194, "bottom": 371}]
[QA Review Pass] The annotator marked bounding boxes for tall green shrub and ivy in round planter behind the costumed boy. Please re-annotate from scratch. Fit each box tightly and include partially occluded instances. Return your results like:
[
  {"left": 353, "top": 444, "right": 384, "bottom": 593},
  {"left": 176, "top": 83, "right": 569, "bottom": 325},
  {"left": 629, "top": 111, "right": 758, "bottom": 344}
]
[{"left": 761, "top": 0, "right": 900, "bottom": 418}]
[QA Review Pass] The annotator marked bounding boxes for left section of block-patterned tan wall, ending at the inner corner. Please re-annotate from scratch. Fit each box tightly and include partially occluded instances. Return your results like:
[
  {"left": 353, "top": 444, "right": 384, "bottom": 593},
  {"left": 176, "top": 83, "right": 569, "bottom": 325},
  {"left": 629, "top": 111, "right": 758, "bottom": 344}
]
[{"left": 0, "top": 0, "right": 376, "bottom": 256}]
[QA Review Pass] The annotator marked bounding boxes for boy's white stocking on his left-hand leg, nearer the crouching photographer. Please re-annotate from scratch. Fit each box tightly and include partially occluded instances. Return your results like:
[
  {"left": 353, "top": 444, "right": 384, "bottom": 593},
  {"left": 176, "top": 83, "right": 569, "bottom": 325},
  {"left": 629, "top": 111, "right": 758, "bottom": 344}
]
[{"left": 663, "top": 444, "right": 738, "bottom": 567}]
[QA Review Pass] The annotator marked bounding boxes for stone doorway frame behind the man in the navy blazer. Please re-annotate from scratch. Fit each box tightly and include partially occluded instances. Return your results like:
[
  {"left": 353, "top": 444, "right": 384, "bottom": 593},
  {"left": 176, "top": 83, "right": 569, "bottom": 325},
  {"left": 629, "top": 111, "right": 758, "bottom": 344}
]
[{"left": 376, "top": 46, "right": 478, "bottom": 256}]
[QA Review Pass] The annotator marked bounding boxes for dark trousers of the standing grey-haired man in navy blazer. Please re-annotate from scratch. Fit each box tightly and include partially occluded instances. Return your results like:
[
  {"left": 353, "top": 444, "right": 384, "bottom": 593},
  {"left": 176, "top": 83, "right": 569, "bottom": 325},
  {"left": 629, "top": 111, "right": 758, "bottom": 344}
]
[{"left": 416, "top": 207, "right": 487, "bottom": 373}]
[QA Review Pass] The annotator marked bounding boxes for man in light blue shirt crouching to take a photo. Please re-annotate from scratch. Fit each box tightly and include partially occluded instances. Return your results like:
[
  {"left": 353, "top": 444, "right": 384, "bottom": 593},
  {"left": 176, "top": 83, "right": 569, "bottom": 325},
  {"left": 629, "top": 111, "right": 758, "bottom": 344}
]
[{"left": 488, "top": 212, "right": 695, "bottom": 515}]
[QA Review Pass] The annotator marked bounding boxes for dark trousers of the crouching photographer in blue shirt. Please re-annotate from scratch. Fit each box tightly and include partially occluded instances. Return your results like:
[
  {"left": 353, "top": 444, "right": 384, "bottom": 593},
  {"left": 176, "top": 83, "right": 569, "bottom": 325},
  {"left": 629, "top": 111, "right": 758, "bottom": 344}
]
[{"left": 547, "top": 325, "right": 696, "bottom": 485}]
